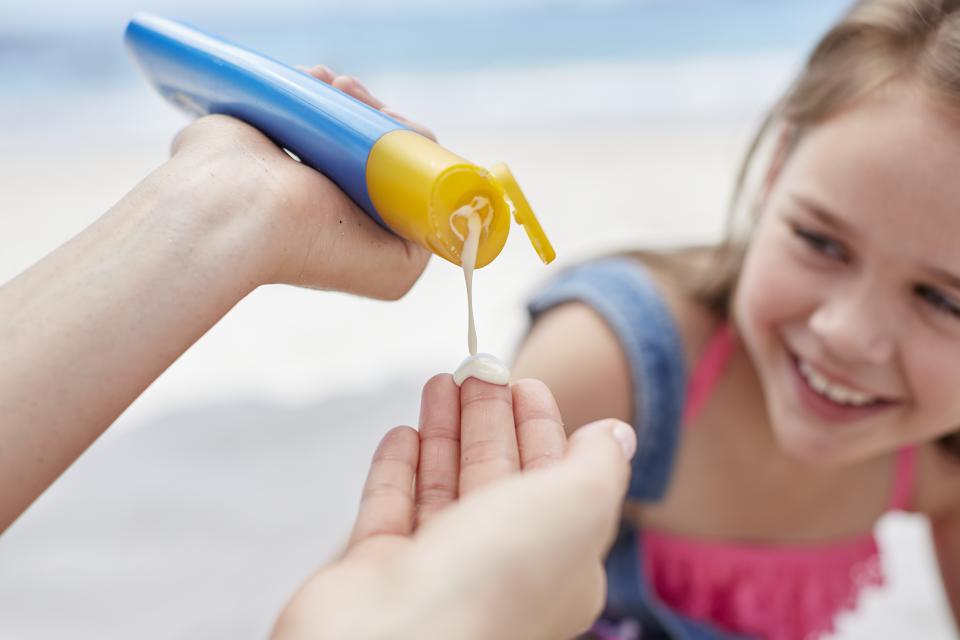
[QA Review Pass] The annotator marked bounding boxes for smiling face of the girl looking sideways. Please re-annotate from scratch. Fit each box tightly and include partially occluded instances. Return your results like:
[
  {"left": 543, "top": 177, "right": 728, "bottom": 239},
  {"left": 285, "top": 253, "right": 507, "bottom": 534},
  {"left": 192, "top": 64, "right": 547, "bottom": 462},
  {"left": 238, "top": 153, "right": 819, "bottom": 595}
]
[{"left": 733, "top": 92, "right": 960, "bottom": 464}]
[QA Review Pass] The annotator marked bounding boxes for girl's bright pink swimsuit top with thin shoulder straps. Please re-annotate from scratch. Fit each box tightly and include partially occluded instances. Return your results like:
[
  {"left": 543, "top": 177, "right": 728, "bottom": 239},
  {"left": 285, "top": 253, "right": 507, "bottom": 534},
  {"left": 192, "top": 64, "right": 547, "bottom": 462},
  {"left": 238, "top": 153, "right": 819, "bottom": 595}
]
[{"left": 641, "top": 325, "right": 916, "bottom": 640}]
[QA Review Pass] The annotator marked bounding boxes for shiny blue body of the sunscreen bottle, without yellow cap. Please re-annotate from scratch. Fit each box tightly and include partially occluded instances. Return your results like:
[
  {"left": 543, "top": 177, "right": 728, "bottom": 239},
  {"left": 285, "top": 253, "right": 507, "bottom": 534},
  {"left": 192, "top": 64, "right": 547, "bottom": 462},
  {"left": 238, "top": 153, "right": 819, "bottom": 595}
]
[{"left": 125, "top": 13, "right": 408, "bottom": 226}]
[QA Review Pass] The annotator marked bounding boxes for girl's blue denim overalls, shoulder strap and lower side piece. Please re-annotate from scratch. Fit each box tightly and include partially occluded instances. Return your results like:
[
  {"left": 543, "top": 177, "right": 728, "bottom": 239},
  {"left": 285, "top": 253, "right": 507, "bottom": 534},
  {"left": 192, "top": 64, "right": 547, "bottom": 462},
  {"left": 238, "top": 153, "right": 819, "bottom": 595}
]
[{"left": 529, "top": 258, "right": 748, "bottom": 640}]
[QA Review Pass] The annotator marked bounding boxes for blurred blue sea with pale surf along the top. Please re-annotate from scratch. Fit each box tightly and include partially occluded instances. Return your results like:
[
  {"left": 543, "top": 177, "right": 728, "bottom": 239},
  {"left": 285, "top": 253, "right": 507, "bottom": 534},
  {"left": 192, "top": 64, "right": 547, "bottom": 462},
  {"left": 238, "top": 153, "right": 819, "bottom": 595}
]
[{"left": 0, "top": 0, "right": 849, "bottom": 128}]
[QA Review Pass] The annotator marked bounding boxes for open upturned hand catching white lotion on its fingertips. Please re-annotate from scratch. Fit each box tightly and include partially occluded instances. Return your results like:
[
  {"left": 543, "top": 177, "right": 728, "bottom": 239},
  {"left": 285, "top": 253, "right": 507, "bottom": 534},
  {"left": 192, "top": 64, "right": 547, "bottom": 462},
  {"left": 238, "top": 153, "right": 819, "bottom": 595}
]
[{"left": 274, "top": 375, "right": 635, "bottom": 640}]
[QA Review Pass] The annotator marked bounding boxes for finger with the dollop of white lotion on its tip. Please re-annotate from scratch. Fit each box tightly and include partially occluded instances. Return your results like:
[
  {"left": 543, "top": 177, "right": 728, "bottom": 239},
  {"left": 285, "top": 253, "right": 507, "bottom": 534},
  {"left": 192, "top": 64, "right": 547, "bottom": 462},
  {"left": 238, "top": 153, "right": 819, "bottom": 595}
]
[{"left": 460, "top": 378, "right": 520, "bottom": 496}]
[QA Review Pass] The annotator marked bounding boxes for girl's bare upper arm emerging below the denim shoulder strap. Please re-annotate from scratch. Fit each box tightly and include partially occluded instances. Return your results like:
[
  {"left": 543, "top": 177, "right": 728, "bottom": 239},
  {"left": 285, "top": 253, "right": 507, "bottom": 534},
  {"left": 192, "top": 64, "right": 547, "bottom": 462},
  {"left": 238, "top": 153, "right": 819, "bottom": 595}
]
[{"left": 512, "top": 303, "right": 633, "bottom": 434}]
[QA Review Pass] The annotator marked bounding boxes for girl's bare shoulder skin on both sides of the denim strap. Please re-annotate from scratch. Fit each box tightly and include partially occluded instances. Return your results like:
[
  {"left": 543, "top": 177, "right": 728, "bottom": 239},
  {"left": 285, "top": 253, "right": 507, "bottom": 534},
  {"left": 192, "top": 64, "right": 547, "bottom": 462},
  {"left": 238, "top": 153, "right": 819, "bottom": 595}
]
[{"left": 513, "top": 255, "right": 715, "bottom": 432}]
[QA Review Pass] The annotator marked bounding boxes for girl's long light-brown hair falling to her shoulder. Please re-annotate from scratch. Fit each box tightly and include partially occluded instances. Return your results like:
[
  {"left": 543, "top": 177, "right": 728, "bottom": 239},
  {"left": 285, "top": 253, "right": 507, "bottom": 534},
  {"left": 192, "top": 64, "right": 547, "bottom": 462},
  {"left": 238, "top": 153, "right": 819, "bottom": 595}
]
[{"left": 634, "top": 0, "right": 960, "bottom": 318}]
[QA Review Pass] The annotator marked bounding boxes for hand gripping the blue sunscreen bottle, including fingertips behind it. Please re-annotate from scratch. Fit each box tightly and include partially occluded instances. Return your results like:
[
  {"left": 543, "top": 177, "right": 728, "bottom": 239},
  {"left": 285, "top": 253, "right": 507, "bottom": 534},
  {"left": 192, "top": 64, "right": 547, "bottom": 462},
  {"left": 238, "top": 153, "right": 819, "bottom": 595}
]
[{"left": 171, "top": 66, "right": 433, "bottom": 299}]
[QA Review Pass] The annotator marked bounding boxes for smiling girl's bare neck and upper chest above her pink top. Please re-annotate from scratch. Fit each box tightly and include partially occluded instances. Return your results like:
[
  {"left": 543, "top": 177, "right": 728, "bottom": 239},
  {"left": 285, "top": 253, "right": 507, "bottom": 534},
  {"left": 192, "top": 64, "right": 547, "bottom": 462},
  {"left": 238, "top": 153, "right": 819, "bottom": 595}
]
[{"left": 631, "top": 328, "right": 892, "bottom": 542}]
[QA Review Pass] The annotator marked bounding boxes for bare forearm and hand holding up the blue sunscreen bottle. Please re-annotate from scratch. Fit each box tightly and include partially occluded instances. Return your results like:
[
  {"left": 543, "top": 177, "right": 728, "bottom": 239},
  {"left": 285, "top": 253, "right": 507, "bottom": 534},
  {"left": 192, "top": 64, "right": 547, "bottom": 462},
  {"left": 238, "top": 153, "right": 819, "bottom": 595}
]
[{"left": 0, "top": 79, "right": 427, "bottom": 531}]
